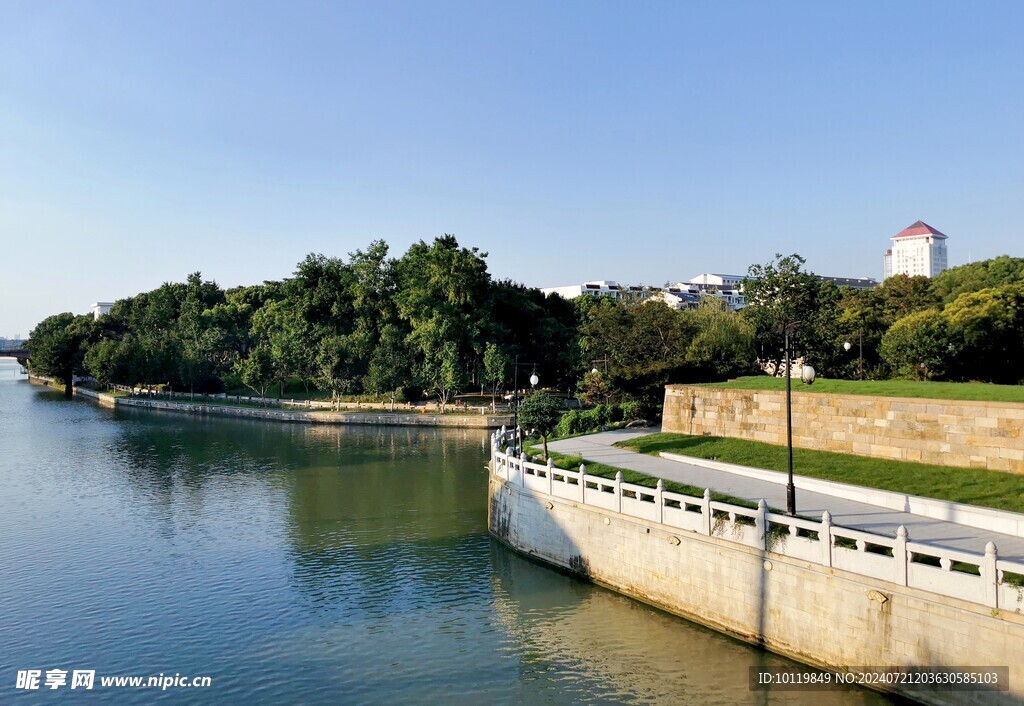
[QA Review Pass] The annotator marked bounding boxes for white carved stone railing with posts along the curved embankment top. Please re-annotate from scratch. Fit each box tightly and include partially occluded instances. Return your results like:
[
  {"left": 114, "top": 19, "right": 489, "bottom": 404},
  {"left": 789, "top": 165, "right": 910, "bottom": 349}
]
[{"left": 490, "top": 427, "right": 1024, "bottom": 613}]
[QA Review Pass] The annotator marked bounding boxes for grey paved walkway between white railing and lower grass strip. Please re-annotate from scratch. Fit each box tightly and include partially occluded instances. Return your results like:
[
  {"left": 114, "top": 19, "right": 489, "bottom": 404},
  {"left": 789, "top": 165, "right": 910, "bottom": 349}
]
[{"left": 548, "top": 429, "right": 1024, "bottom": 562}]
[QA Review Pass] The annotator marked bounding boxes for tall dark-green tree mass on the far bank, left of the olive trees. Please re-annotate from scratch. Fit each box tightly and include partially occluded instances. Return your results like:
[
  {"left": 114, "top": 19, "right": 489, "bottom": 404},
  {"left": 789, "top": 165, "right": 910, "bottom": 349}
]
[{"left": 32, "top": 236, "right": 579, "bottom": 405}]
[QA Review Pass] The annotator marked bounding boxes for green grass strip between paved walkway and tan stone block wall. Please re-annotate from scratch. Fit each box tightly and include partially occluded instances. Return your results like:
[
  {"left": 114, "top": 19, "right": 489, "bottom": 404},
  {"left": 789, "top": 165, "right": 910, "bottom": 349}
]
[{"left": 614, "top": 433, "right": 1024, "bottom": 512}]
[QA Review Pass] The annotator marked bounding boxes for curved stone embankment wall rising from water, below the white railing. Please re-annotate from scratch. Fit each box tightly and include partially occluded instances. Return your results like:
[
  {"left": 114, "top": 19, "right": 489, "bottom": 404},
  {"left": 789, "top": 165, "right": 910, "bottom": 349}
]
[{"left": 488, "top": 475, "right": 1024, "bottom": 704}]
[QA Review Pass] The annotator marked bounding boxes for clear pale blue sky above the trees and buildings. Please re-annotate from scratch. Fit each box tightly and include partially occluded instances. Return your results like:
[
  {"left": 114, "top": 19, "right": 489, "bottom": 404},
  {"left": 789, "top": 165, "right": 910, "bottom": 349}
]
[{"left": 0, "top": 0, "right": 1024, "bottom": 336}]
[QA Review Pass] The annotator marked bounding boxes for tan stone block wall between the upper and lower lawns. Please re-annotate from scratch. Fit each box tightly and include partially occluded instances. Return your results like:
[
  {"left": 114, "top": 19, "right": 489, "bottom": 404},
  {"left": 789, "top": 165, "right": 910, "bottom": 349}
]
[{"left": 662, "top": 385, "right": 1024, "bottom": 473}]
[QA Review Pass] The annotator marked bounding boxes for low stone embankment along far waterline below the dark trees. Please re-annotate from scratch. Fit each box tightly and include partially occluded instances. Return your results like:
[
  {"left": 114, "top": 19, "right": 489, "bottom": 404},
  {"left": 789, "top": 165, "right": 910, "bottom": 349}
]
[{"left": 29, "top": 375, "right": 512, "bottom": 429}]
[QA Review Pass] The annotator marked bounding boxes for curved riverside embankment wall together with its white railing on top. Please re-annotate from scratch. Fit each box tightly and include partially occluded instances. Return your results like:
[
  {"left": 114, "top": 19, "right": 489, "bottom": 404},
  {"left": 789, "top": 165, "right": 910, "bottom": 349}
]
[{"left": 488, "top": 438, "right": 1024, "bottom": 705}]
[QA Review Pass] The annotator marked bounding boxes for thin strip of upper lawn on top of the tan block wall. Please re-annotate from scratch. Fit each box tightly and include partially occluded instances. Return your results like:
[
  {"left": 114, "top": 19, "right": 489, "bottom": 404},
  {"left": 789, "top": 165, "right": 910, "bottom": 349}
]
[{"left": 708, "top": 375, "right": 1024, "bottom": 403}]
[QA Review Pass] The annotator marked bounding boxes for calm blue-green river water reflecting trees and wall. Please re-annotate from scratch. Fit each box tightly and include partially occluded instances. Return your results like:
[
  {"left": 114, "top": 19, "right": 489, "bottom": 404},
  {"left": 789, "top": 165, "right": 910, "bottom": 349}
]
[{"left": 0, "top": 359, "right": 888, "bottom": 704}]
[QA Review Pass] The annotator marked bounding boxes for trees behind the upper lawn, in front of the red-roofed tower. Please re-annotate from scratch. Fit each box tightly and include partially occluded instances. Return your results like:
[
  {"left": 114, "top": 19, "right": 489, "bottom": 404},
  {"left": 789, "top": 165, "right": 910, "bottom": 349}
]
[{"left": 743, "top": 255, "right": 1024, "bottom": 384}]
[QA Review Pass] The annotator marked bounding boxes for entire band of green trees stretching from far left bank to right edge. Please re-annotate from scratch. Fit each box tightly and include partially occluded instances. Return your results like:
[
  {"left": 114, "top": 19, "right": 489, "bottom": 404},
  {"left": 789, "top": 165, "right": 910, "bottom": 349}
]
[{"left": 30, "top": 236, "right": 1024, "bottom": 410}]
